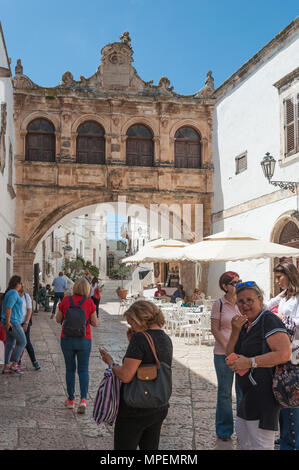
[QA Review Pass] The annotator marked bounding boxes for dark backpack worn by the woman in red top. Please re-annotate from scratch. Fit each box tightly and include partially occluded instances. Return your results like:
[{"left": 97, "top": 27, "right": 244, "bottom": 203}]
[{"left": 63, "top": 296, "right": 88, "bottom": 338}]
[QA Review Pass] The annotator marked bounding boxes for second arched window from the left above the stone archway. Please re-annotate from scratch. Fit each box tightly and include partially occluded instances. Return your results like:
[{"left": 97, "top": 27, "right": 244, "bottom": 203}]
[{"left": 76, "top": 122, "right": 105, "bottom": 165}]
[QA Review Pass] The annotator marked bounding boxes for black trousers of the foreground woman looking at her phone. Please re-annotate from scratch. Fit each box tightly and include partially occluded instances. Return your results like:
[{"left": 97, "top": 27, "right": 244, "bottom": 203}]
[{"left": 114, "top": 409, "right": 168, "bottom": 450}]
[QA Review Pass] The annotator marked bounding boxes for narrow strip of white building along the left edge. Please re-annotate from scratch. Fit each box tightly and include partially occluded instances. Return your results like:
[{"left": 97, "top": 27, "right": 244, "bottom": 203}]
[{"left": 0, "top": 23, "right": 17, "bottom": 292}]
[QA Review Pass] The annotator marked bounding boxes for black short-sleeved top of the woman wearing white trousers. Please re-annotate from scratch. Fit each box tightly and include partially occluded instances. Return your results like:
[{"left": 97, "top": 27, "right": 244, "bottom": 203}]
[{"left": 235, "top": 311, "right": 287, "bottom": 431}]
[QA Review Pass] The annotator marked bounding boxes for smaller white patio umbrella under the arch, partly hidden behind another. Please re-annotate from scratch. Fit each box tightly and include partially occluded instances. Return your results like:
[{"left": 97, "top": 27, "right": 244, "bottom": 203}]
[{"left": 121, "top": 238, "right": 190, "bottom": 264}]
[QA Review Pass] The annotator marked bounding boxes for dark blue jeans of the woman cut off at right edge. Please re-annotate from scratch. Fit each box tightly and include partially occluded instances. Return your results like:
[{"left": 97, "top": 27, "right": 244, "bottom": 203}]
[{"left": 279, "top": 408, "right": 299, "bottom": 450}]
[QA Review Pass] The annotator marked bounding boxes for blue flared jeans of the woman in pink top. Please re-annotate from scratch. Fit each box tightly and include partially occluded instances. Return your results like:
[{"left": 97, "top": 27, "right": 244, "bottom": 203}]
[{"left": 214, "top": 354, "right": 242, "bottom": 438}]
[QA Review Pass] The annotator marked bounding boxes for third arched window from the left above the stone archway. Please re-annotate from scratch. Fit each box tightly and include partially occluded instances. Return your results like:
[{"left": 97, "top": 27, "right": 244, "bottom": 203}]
[{"left": 126, "top": 124, "right": 154, "bottom": 166}]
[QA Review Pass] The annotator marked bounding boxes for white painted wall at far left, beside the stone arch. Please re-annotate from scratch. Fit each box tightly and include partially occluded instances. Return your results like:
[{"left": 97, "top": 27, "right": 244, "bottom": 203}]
[{"left": 0, "top": 30, "right": 17, "bottom": 291}]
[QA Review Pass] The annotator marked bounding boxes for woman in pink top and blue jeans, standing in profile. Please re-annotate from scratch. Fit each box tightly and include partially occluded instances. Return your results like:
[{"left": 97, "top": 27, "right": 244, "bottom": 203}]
[{"left": 211, "top": 271, "right": 242, "bottom": 441}]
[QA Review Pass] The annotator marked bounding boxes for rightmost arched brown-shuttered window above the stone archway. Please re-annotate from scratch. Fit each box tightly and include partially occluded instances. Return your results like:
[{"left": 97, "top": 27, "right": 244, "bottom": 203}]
[{"left": 174, "top": 127, "right": 201, "bottom": 168}]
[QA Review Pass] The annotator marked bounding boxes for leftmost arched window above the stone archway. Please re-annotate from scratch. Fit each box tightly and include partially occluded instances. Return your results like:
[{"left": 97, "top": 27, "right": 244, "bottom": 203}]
[{"left": 25, "top": 119, "right": 56, "bottom": 162}]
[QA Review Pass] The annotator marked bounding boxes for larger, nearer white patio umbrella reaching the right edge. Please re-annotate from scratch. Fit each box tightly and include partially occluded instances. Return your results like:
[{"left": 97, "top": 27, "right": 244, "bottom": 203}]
[{"left": 176, "top": 230, "right": 299, "bottom": 263}]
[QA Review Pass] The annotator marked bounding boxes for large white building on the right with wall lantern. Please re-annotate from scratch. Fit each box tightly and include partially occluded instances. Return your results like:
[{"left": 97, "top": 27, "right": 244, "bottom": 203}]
[{"left": 208, "top": 17, "right": 299, "bottom": 298}]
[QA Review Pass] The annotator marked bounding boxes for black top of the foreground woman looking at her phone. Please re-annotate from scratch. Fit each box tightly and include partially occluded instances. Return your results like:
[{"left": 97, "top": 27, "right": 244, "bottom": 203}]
[{"left": 118, "top": 330, "right": 173, "bottom": 418}]
